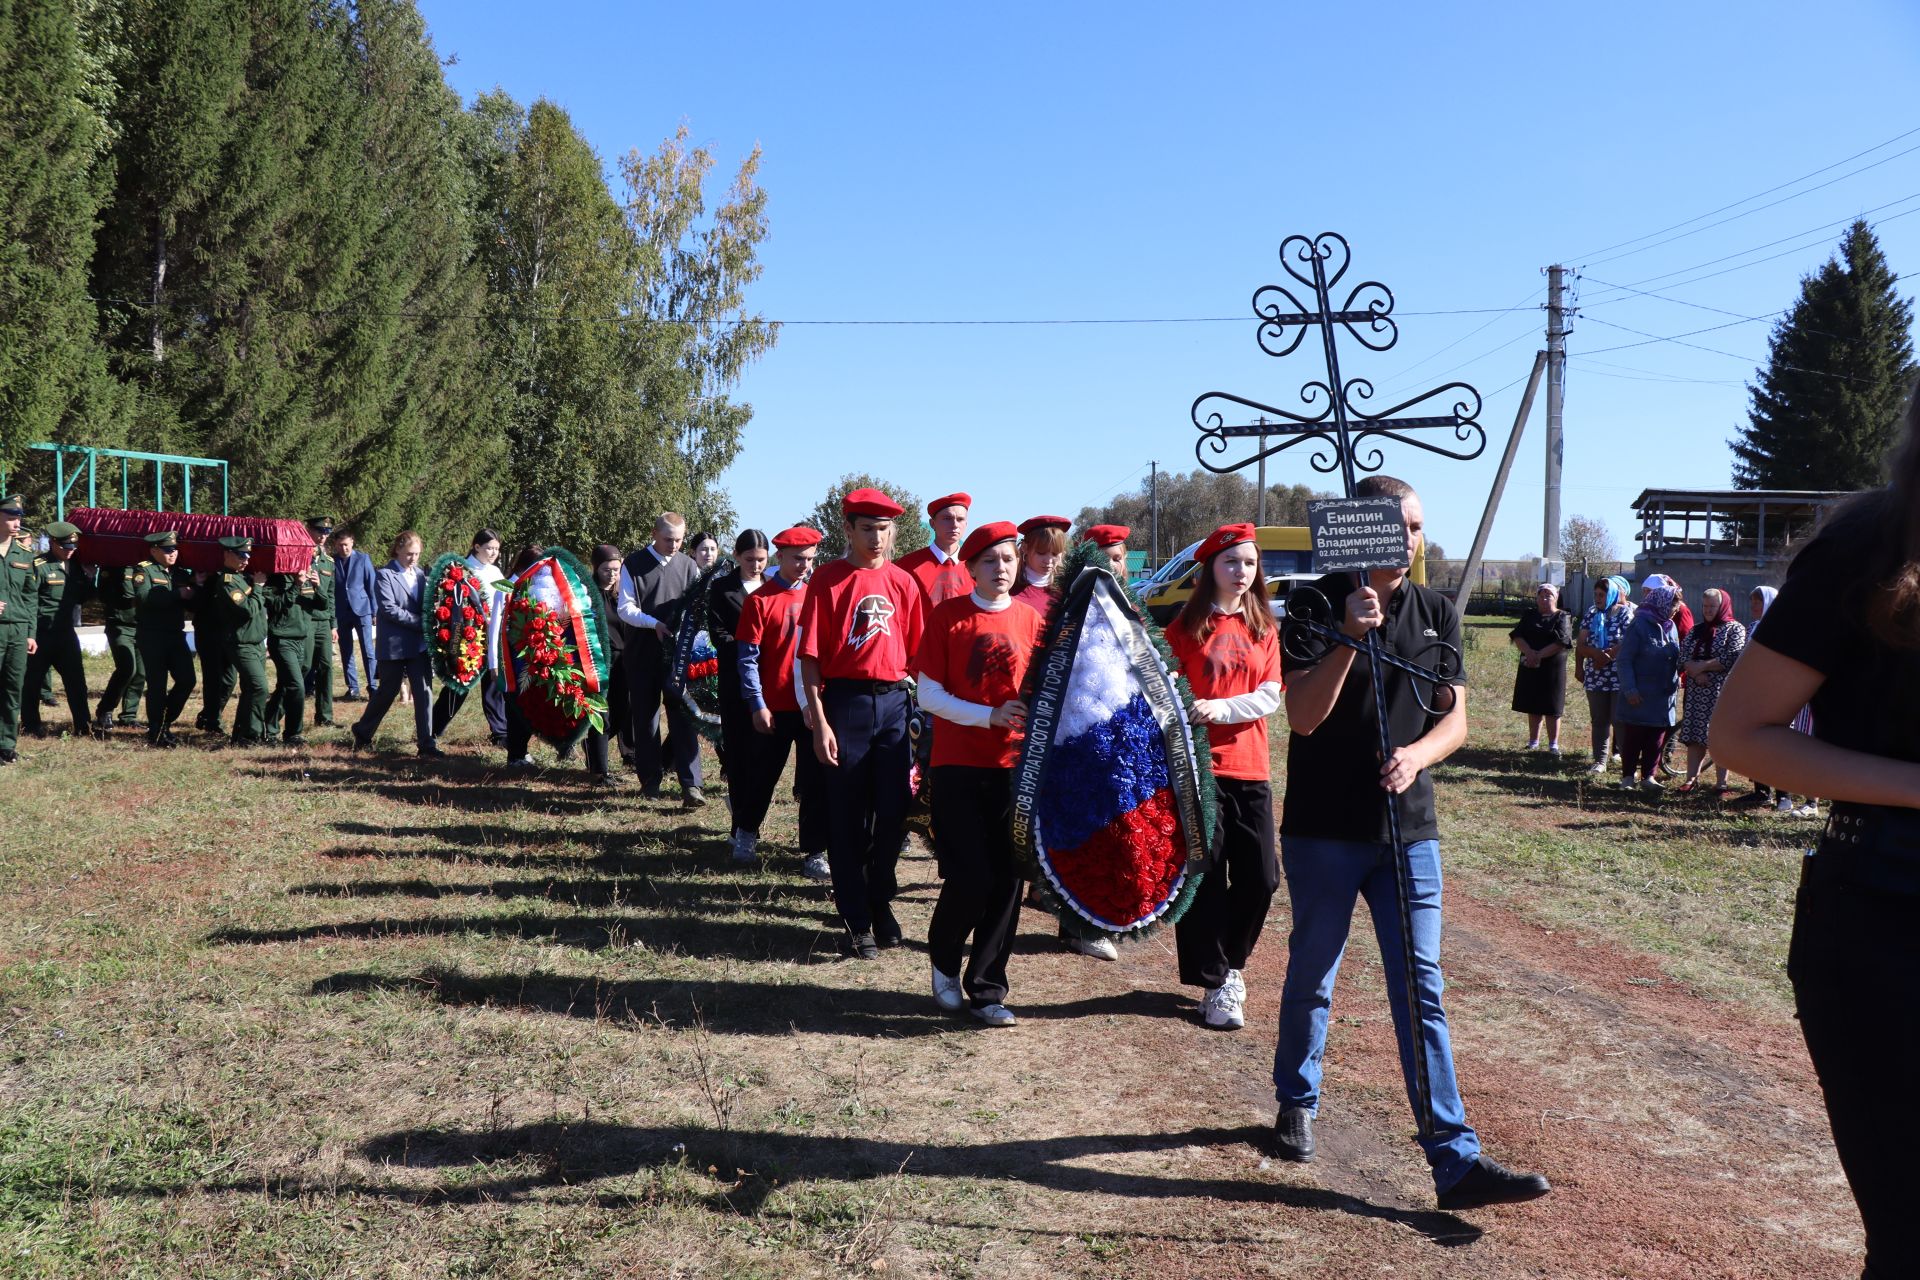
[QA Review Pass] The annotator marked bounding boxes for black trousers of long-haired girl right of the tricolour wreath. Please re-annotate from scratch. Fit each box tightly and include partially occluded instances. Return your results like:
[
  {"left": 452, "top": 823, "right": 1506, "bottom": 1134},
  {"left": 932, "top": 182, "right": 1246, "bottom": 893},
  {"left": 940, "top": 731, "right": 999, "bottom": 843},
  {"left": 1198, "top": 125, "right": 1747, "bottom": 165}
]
[{"left": 1173, "top": 777, "right": 1281, "bottom": 988}]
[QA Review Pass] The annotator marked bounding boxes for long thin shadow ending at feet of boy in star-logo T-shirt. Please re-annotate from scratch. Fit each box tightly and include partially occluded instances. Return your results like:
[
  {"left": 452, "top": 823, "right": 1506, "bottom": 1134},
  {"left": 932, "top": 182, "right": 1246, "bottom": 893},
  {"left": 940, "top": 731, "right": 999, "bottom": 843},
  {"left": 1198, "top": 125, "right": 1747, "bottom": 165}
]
[{"left": 207, "top": 913, "right": 839, "bottom": 961}]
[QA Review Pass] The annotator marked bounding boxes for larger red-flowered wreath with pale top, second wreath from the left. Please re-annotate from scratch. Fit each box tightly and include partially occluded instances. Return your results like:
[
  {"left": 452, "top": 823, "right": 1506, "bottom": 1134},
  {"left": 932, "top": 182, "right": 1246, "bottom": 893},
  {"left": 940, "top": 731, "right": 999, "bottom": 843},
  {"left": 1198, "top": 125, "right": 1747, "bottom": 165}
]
[{"left": 501, "top": 547, "right": 609, "bottom": 747}]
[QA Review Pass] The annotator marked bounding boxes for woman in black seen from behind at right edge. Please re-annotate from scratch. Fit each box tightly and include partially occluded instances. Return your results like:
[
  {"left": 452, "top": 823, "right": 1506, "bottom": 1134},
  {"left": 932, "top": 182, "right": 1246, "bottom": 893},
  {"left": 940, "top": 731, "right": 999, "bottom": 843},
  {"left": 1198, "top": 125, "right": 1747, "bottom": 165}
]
[{"left": 1709, "top": 385, "right": 1920, "bottom": 1278}]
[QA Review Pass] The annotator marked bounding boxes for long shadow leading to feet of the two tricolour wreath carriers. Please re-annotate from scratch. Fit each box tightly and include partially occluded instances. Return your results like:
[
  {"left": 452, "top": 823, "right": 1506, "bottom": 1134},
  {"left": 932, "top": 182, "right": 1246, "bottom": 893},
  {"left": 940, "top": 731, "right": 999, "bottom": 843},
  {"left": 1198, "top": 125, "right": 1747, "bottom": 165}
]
[{"left": 311, "top": 969, "right": 1190, "bottom": 1038}]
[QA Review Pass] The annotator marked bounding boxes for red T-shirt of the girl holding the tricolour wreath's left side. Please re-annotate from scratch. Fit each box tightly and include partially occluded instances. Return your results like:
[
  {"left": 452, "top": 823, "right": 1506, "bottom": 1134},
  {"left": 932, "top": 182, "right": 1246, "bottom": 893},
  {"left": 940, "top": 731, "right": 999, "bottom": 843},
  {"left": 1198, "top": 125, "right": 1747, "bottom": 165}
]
[{"left": 914, "top": 591, "right": 1046, "bottom": 770}]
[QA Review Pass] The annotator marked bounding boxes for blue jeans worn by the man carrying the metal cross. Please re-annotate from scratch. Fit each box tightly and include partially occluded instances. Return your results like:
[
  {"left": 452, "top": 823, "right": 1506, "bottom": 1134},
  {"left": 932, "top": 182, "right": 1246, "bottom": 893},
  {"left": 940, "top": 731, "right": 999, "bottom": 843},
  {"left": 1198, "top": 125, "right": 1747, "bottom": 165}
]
[{"left": 1273, "top": 835, "right": 1480, "bottom": 1192}]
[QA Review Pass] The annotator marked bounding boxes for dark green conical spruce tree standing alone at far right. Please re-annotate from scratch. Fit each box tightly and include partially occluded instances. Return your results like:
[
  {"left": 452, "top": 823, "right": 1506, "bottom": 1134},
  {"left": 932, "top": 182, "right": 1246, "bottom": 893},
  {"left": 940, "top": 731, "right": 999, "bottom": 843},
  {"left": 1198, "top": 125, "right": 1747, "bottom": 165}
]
[{"left": 1732, "top": 221, "right": 1916, "bottom": 489}]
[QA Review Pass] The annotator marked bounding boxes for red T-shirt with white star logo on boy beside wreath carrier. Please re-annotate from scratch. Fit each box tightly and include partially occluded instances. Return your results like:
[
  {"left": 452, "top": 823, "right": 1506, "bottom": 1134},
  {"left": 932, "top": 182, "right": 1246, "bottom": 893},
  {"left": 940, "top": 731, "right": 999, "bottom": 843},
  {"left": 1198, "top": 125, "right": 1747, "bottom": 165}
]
[{"left": 801, "top": 560, "right": 927, "bottom": 679}]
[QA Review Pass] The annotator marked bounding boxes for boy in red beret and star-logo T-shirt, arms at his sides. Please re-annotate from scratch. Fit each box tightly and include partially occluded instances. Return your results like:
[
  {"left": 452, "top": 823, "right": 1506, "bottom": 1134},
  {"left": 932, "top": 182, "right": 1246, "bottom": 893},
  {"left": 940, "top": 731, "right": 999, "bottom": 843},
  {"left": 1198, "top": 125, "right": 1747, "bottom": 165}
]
[{"left": 801, "top": 489, "right": 925, "bottom": 960}]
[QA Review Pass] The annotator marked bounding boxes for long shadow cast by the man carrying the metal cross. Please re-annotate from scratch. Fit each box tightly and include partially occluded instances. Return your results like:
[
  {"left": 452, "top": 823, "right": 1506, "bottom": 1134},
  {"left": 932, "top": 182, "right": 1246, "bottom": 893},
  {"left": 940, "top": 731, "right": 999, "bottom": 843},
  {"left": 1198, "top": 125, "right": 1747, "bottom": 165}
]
[{"left": 337, "top": 1123, "right": 1482, "bottom": 1247}]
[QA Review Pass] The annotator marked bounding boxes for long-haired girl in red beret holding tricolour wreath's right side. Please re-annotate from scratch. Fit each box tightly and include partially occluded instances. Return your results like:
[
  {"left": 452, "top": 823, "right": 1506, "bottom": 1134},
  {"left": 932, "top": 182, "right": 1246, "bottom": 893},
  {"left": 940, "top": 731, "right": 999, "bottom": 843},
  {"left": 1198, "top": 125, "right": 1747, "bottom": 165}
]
[{"left": 1167, "top": 524, "right": 1281, "bottom": 1031}]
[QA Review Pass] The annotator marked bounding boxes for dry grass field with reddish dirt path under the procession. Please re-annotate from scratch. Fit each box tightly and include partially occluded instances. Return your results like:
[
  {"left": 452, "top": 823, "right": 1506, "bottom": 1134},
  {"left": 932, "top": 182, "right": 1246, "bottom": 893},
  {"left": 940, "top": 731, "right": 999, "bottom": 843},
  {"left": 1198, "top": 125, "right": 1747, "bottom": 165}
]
[{"left": 0, "top": 626, "right": 1859, "bottom": 1278}]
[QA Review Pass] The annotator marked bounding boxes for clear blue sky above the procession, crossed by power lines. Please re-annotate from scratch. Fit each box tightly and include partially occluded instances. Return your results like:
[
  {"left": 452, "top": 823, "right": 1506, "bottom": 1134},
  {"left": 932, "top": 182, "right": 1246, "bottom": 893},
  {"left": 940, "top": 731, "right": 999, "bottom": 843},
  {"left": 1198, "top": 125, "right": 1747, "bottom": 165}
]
[{"left": 422, "top": 0, "right": 1920, "bottom": 557}]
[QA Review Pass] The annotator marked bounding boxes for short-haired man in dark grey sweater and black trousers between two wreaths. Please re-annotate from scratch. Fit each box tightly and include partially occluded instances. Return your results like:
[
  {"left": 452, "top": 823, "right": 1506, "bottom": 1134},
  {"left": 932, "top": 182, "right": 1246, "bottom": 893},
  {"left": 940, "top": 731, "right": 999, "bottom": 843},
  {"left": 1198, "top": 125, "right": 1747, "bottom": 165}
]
[{"left": 616, "top": 510, "right": 707, "bottom": 808}]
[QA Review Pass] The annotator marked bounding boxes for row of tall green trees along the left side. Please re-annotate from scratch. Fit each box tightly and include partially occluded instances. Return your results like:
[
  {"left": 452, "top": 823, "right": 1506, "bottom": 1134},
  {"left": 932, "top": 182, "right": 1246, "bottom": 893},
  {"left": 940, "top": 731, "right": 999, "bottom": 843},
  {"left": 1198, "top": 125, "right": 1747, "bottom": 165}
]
[{"left": 0, "top": 0, "right": 778, "bottom": 547}]
